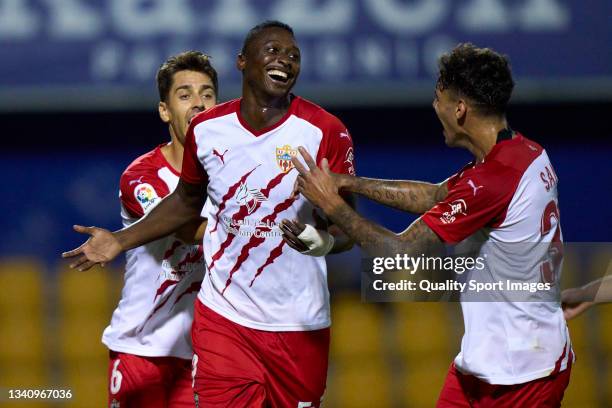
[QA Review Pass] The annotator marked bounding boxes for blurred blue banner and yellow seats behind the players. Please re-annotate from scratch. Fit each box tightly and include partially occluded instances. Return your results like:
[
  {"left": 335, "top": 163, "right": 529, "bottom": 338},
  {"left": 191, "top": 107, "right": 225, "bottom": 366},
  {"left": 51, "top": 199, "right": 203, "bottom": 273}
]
[{"left": 0, "top": 0, "right": 612, "bottom": 408}]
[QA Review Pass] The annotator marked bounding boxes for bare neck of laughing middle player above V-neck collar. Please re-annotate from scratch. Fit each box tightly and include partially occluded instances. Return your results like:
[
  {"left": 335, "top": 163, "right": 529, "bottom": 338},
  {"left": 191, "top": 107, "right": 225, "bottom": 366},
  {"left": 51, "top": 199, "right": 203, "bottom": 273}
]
[{"left": 240, "top": 89, "right": 291, "bottom": 130}]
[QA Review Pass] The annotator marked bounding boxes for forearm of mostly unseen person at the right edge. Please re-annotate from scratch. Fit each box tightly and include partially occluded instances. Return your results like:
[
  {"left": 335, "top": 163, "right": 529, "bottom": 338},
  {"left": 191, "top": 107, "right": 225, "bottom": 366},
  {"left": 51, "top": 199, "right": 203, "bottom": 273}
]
[{"left": 561, "top": 276, "right": 612, "bottom": 320}]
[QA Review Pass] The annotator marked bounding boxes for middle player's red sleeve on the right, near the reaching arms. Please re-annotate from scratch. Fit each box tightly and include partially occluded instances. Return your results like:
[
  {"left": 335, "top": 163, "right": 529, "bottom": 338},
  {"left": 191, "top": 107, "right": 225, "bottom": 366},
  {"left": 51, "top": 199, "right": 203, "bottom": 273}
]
[{"left": 317, "top": 115, "right": 355, "bottom": 176}]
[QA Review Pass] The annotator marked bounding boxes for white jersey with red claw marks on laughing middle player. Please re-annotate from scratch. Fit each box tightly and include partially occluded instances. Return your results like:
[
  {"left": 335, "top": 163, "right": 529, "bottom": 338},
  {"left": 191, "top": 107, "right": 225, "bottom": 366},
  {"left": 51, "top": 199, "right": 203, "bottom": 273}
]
[{"left": 181, "top": 97, "right": 354, "bottom": 331}]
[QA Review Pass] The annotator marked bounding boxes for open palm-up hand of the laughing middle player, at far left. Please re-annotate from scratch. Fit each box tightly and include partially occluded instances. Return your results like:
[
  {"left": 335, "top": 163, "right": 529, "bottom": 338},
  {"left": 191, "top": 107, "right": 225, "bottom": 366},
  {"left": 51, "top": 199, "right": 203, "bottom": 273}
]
[{"left": 62, "top": 225, "right": 122, "bottom": 271}]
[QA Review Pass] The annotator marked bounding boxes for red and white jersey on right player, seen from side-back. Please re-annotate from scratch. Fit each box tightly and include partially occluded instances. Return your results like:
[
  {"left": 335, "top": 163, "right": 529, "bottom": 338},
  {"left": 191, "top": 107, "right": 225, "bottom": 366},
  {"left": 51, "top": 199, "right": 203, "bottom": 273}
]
[{"left": 422, "top": 134, "right": 573, "bottom": 384}]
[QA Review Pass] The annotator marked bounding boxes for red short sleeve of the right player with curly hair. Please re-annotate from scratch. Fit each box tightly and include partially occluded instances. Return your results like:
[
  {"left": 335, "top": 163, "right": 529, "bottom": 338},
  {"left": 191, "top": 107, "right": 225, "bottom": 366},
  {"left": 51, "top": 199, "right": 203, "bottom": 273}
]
[{"left": 422, "top": 167, "right": 515, "bottom": 243}]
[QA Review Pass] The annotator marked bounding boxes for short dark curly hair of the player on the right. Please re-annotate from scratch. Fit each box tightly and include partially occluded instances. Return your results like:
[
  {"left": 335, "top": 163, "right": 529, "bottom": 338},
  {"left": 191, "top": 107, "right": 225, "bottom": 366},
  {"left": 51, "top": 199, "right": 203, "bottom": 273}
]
[{"left": 437, "top": 43, "right": 514, "bottom": 115}]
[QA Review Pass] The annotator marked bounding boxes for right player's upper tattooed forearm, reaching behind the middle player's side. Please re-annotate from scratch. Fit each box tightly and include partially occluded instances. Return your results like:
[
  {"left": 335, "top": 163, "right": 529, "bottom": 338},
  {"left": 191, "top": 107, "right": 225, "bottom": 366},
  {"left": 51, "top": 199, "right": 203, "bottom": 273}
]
[{"left": 332, "top": 173, "right": 448, "bottom": 214}]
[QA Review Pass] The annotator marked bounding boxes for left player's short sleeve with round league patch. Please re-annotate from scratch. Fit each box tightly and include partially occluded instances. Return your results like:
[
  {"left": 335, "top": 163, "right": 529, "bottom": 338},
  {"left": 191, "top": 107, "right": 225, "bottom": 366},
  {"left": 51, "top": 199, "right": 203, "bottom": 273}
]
[{"left": 119, "top": 172, "right": 168, "bottom": 218}]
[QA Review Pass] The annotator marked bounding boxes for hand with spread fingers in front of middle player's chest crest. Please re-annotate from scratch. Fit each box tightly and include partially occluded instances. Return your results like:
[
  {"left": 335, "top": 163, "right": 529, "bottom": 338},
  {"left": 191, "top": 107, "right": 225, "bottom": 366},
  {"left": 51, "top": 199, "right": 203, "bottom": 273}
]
[{"left": 291, "top": 146, "right": 342, "bottom": 211}]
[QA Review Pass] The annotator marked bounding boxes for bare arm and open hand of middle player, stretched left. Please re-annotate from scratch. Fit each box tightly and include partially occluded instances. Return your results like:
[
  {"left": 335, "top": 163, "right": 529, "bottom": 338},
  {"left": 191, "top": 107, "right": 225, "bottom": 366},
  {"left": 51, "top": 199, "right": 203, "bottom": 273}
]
[{"left": 62, "top": 180, "right": 206, "bottom": 271}]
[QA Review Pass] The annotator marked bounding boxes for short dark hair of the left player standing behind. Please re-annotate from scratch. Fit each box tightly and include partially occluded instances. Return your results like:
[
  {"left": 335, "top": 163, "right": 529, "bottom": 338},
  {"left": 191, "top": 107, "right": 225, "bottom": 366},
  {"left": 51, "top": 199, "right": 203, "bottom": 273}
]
[{"left": 155, "top": 51, "right": 219, "bottom": 102}]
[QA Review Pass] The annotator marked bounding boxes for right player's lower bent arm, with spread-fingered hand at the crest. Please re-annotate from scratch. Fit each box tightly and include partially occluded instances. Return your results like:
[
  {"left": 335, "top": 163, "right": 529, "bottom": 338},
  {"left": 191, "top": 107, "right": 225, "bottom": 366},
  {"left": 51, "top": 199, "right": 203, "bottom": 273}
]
[{"left": 292, "top": 147, "right": 442, "bottom": 256}]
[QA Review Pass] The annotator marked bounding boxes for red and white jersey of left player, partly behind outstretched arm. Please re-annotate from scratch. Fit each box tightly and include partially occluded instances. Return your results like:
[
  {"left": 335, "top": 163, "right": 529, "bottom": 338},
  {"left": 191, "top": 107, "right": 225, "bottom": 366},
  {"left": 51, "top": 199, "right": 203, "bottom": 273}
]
[{"left": 102, "top": 146, "right": 204, "bottom": 359}]
